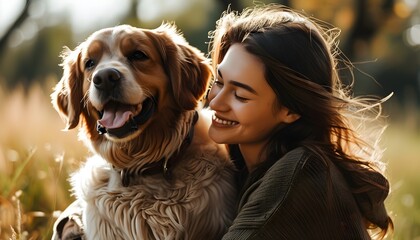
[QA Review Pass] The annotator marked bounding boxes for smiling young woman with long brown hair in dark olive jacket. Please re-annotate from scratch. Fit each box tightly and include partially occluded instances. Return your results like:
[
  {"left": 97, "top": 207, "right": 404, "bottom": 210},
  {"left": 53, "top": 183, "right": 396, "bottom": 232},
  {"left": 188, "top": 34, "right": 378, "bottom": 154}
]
[{"left": 208, "top": 5, "right": 393, "bottom": 239}]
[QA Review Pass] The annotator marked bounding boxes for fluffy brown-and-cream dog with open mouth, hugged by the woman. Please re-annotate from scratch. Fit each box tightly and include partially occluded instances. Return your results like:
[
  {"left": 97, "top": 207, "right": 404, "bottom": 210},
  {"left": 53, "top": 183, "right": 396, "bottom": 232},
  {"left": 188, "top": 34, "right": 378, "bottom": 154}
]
[{"left": 51, "top": 23, "right": 236, "bottom": 239}]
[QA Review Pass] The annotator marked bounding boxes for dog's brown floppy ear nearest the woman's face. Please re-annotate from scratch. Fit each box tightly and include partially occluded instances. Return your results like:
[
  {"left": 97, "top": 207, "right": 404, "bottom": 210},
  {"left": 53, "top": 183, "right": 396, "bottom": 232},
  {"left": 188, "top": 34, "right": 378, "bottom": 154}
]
[{"left": 156, "top": 24, "right": 211, "bottom": 110}]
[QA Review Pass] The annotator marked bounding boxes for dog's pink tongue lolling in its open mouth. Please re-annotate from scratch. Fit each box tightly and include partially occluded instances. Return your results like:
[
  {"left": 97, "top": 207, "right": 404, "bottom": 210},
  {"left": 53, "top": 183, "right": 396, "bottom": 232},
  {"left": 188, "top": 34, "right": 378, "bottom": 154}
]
[{"left": 98, "top": 104, "right": 138, "bottom": 129}]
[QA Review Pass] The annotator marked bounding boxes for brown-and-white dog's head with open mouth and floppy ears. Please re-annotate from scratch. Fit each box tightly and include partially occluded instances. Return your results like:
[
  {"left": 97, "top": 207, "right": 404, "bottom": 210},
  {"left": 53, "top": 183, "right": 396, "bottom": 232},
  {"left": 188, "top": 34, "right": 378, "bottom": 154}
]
[{"left": 52, "top": 24, "right": 211, "bottom": 167}]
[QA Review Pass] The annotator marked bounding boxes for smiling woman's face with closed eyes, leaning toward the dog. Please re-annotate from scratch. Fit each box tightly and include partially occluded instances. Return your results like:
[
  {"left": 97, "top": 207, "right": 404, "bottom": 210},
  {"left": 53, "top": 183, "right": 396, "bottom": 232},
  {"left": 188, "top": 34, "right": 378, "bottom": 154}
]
[{"left": 209, "top": 44, "right": 289, "bottom": 147}]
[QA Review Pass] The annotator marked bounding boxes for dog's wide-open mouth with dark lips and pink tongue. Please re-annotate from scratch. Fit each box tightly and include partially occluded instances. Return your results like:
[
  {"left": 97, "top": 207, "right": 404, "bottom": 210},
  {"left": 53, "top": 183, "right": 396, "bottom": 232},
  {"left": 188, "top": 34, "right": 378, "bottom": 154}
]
[{"left": 97, "top": 98, "right": 156, "bottom": 138}]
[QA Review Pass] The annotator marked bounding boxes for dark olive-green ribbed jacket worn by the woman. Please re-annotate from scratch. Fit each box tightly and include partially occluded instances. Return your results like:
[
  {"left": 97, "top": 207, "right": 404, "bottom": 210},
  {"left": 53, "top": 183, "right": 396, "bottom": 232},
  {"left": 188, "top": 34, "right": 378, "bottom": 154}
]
[{"left": 223, "top": 148, "right": 388, "bottom": 240}]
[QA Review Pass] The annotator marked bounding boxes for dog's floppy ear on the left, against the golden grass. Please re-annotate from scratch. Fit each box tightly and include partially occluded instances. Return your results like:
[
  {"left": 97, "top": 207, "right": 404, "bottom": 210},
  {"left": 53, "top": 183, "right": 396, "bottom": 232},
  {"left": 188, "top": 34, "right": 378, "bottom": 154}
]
[{"left": 51, "top": 48, "right": 83, "bottom": 130}]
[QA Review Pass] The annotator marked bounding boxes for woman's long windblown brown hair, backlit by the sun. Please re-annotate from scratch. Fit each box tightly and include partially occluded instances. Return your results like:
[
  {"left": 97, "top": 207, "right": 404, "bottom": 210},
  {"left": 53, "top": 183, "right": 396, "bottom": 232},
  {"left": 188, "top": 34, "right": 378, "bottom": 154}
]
[{"left": 209, "top": 4, "right": 393, "bottom": 238}]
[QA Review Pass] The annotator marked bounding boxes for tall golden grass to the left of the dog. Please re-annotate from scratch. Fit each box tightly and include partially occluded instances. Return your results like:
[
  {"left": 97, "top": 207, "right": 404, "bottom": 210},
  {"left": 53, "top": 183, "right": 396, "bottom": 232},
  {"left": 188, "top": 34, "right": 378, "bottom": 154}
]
[{"left": 0, "top": 83, "right": 88, "bottom": 239}]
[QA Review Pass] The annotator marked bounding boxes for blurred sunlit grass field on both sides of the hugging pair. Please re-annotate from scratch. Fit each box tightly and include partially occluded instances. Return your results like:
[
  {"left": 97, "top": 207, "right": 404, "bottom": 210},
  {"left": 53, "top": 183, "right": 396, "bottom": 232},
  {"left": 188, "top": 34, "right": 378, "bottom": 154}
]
[{"left": 0, "top": 84, "right": 420, "bottom": 240}]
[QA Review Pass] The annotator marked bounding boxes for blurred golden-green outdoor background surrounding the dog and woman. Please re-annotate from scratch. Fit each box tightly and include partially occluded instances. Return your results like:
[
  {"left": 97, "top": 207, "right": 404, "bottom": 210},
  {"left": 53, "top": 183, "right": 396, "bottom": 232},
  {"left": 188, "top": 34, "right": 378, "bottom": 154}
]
[{"left": 0, "top": 0, "right": 420, "bottom": 240}]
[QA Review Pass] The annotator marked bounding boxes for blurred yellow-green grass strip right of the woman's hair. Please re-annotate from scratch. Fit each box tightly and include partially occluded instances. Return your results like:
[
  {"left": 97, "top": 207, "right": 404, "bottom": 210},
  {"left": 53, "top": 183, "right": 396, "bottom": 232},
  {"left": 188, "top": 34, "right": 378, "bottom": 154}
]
[{"left": 384, "top": 124, "right": 420, "bottom": 239}]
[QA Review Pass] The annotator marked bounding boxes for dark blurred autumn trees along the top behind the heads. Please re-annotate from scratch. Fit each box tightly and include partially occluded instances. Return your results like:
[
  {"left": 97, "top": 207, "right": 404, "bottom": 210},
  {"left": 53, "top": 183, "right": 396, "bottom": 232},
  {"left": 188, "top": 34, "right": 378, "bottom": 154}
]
[{"left": 0, "top": 0, "right": 420, "bottom": 106}]
